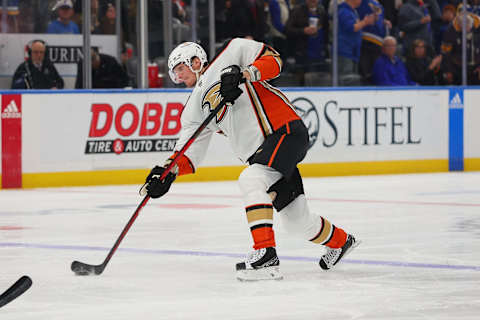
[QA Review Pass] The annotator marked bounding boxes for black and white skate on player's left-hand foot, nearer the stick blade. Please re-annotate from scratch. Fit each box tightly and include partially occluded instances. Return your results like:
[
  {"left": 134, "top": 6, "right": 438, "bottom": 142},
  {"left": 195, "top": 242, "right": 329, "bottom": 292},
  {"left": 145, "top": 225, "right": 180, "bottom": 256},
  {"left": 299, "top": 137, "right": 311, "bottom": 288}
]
[{"left": 236, "top": 247, "right": 283, "bottom": 281}]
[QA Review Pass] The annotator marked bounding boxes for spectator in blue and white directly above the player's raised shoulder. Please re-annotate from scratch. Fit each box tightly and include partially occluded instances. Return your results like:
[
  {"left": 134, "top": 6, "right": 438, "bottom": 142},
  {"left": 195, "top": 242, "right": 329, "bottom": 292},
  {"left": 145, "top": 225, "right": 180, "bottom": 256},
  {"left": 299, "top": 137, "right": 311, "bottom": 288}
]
[{"left": 265, "top": 0, "right": 290, "bottom": 61}]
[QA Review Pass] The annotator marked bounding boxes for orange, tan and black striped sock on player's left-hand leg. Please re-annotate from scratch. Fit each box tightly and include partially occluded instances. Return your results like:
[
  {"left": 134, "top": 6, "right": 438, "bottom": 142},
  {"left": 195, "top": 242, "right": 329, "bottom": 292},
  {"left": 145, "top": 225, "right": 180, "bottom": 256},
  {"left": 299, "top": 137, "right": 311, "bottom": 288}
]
[{"left": 245, "top": 204, "right": 275, "bottom": 250}]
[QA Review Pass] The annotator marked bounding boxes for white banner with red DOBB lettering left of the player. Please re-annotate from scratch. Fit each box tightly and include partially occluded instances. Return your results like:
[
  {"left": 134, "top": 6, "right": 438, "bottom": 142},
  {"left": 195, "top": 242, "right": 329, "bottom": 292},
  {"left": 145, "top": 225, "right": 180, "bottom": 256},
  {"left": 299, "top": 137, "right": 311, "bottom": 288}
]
[{"left": 23, "top": 92, "right": 191, "bottom": 172}]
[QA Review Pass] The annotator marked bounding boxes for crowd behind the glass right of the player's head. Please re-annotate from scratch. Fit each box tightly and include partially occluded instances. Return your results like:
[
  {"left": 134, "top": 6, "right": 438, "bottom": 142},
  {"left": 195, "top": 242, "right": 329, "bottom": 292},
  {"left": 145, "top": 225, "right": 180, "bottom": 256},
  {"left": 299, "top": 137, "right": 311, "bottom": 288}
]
[{"left": 216, "top": 0, "right": 480, "bottom": 86}]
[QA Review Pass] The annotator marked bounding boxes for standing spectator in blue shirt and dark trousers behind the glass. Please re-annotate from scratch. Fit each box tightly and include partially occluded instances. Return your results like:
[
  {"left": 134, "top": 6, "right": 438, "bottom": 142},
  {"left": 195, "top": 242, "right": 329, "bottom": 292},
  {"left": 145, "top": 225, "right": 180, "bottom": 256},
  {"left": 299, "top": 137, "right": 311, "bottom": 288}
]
[{"left": 357, "top": 0, "right": 392, "bottom": 82}]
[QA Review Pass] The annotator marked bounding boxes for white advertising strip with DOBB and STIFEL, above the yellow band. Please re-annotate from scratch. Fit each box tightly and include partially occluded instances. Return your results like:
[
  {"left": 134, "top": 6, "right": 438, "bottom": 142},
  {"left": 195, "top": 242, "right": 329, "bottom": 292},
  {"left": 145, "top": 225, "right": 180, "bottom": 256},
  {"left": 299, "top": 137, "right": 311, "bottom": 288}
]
[{"left": 18, "top": 90, "right": 448, "bottom": 178}]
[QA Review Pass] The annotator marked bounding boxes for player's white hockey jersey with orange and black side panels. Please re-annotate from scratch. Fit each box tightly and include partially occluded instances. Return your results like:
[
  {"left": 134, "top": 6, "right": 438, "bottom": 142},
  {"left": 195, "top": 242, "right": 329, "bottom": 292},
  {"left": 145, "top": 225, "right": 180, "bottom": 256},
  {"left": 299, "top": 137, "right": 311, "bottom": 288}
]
[{"left": 175, "top": 38, "right": 300, "bottom": 168}]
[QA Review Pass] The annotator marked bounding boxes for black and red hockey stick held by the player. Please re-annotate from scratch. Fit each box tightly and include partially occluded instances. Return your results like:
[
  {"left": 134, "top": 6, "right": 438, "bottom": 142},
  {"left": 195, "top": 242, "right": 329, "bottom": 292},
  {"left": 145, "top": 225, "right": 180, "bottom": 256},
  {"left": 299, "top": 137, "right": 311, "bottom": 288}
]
[{"left": 71, "top": 100, "right": 230, "bottom": 276}]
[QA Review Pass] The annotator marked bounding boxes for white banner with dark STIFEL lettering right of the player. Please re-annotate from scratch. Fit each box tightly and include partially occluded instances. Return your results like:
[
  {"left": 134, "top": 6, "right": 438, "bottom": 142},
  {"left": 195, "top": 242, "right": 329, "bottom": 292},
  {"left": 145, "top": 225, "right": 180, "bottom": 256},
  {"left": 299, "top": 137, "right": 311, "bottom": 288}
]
[{"left": 286, "top": 90, "right": 448, "bottom": 163}]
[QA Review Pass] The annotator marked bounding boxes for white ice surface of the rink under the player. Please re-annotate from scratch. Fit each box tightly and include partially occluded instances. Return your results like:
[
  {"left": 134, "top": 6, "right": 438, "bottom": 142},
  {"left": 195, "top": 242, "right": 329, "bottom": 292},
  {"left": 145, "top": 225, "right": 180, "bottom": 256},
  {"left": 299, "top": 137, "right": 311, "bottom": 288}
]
[{"left": 0, "top": 173, "right": 480, "bottom": 320}]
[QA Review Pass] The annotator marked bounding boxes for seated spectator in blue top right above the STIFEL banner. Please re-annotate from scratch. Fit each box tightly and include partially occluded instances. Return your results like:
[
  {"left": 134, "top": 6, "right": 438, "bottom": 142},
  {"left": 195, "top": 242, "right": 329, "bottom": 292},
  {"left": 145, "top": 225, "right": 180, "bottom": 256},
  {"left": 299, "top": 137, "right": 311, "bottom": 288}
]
[{"left": 373, "top": 36, "right": 416, "bottom": 86}]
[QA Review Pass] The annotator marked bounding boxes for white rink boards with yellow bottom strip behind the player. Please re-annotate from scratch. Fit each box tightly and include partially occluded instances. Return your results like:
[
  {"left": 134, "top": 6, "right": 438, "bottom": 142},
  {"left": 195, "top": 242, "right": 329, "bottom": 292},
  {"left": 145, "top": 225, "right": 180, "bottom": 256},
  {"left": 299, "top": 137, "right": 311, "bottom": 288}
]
[{"left": 0, "top": 88, "right": 480, "bottom": 188}]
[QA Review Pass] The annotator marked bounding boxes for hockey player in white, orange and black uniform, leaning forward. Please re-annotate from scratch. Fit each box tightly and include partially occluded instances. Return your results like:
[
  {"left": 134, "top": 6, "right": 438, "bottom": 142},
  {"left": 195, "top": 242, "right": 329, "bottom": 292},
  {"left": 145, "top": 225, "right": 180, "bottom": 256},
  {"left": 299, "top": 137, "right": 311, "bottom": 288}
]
[{"left": 140, "top": 38, "right": 358, "bottom": 281}]
